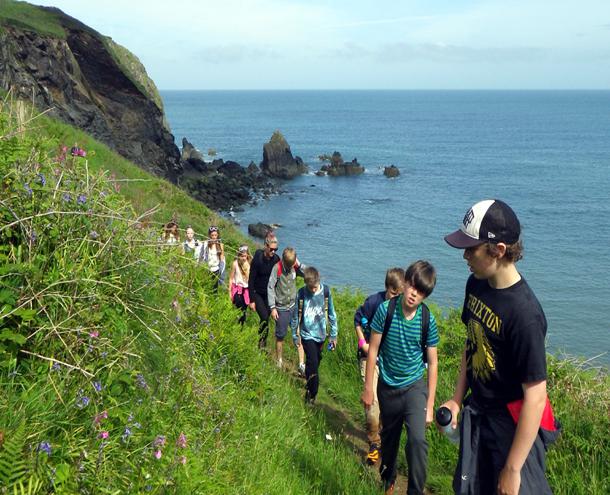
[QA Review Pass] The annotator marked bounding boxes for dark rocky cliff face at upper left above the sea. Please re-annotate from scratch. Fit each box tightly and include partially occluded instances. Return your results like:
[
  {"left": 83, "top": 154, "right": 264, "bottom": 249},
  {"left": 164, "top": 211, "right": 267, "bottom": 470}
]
[{"left": 0, "top": 6, "right": 182, "bottom": 182}]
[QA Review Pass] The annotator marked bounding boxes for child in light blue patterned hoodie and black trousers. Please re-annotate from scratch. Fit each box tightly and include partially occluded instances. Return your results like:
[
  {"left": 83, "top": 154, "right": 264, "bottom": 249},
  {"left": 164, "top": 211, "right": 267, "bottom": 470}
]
[{"left": 290, "top": 266, "right": 338, "bottom": 404}]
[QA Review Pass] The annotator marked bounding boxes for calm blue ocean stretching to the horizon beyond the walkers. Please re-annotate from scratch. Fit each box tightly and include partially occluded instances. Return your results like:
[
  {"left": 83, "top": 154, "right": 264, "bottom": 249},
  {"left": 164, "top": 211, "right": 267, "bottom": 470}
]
[{"left": 161, "top": 91, "right": 610, "bottom": 367}]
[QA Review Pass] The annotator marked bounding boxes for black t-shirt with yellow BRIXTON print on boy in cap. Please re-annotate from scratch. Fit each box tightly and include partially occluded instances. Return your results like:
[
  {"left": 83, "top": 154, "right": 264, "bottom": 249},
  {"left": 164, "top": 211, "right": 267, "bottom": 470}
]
[{"left": 462, "top": 276, "right": 547, "bottom": 408}]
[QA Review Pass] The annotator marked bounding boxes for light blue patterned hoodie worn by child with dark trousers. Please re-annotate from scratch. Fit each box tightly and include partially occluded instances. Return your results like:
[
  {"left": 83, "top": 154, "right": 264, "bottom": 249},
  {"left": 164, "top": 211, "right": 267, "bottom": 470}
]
[{"left": 290, "top": 284, "right": 338, "bottom": 342}]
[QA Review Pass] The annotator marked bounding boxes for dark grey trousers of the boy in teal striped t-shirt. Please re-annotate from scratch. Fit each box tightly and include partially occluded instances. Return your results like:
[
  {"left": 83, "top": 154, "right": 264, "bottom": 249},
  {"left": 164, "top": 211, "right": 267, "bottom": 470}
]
[{"left": 377, "top": 377, "right": 428, "bottom": 495}]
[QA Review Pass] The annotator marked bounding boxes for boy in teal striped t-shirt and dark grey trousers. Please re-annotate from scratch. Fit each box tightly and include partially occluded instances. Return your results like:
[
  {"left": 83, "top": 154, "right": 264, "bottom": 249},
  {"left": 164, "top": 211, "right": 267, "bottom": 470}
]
[{"left": 362, "top": 260, "right": 439, "bottom": 495}]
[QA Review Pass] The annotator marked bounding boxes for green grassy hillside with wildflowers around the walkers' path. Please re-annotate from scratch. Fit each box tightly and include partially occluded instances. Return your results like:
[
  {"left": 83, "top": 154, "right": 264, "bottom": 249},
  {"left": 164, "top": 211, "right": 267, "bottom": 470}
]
[{"left": 0, "top": 95, "right": 610, "bottom": 494}]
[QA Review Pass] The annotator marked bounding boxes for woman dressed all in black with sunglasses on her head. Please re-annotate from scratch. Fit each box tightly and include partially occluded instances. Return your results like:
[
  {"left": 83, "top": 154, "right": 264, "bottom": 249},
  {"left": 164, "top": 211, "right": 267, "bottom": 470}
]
[{"left": 248, "top": 232, "right": 280, "bottom": 349}]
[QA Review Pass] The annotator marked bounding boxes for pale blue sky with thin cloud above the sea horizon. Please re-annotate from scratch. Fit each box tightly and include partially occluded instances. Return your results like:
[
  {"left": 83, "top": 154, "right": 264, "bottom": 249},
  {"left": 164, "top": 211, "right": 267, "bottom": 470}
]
[{"left": 34, "top": 0, "right": 610, "bottom": 89}]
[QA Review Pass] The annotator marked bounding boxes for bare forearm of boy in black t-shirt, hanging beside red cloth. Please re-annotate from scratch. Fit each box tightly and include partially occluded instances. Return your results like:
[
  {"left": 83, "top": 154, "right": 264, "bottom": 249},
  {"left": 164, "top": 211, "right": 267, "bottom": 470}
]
[{"left": 498, "top": 380, "right": 546, "bottom": 495}]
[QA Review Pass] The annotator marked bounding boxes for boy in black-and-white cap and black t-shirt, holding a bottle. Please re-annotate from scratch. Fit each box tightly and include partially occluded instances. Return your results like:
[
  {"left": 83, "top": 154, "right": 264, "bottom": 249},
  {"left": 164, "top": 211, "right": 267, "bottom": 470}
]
[{"left": 443, "top": 200, "right": 558, "bottom": 495}]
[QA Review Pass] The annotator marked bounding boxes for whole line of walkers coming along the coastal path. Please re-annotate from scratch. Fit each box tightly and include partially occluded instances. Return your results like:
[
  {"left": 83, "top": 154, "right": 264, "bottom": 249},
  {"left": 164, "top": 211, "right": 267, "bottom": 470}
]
[{"left": 163, "top": 200, "right": 560, "bottom": 495}]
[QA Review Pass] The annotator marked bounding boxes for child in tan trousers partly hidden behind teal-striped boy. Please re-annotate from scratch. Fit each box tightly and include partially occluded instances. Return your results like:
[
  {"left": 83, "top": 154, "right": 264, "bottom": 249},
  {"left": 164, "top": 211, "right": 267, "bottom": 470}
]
[{"left": 354, "top": 268, "right": 405, "bottom": 466}]
